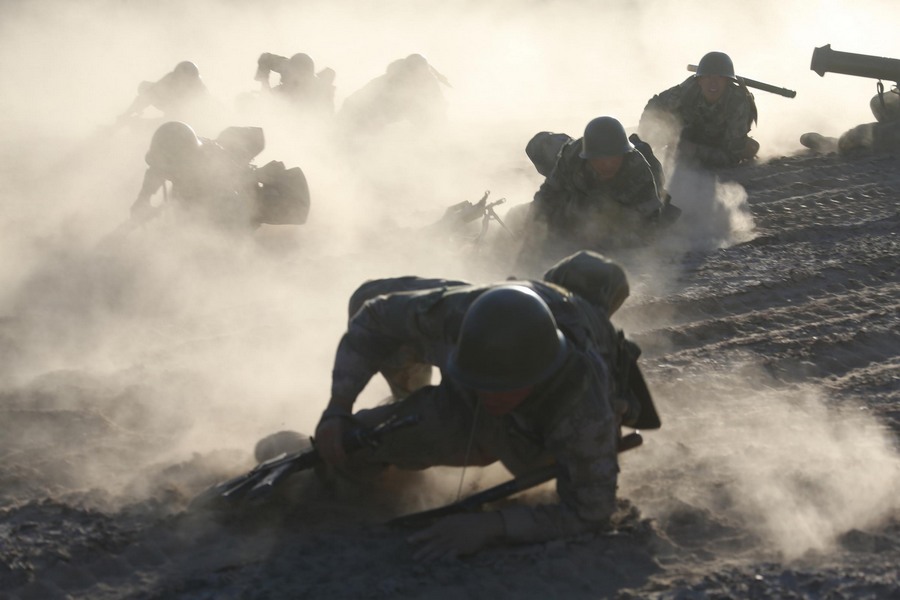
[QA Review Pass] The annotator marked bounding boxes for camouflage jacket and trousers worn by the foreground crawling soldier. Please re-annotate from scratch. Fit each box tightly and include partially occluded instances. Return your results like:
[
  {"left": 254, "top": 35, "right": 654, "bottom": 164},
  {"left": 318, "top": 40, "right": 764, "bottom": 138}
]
[{"left": 332, "top": 278, "right": 621, "bottom": 541}]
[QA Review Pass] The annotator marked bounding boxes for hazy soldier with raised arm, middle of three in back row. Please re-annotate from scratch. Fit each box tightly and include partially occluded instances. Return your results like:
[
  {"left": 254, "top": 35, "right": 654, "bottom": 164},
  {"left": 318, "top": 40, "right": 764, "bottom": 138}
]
[{"left": 255, "top": 52, "right": 335, "bottom": 116}]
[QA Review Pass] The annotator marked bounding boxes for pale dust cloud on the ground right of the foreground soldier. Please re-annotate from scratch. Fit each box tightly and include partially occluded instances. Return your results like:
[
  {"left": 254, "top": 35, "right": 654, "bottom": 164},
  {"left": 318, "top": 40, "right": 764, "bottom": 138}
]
[{"left": 620, "top": 378, "right": 900, "bottom": 560}]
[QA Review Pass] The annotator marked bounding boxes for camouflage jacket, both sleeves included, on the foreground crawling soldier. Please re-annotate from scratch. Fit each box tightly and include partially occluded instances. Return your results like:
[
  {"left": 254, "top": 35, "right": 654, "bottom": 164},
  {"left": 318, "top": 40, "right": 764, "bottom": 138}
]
[{"left": 332, "top": 281, "right": 619, "bottom": 541}]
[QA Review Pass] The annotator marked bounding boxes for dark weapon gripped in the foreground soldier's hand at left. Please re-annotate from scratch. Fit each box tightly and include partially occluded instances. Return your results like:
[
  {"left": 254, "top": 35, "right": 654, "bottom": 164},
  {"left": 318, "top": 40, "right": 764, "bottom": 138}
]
[{"left": 188, "top": 415, "right": 421, "bottom": 510}]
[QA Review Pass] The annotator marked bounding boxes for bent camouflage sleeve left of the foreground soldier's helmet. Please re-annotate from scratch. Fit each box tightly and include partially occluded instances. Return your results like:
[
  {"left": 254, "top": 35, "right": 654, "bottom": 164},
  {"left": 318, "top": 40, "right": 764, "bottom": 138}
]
[{"left": 331, "top": 286, "right": 468, "bottom": 408}]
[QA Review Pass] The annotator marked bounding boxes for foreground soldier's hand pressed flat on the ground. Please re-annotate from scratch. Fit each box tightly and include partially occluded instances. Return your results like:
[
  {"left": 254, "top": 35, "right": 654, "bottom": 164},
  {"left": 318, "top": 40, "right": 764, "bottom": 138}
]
[{"left": 406, "top": 511, "right": 504, "bottom": 562}]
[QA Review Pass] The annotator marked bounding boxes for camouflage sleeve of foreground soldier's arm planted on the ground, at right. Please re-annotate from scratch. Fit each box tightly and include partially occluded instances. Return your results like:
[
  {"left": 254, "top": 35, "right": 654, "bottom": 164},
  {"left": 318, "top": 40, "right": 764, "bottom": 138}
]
[{"left": 500, "top": 357, "right": 619, "bottom": 542}]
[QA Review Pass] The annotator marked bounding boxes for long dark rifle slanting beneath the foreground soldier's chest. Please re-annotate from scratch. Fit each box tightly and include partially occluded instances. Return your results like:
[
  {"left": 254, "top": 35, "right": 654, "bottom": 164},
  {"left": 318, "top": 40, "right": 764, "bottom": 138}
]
[{"left": 388, "top": 431, "right": 644, "bottom": 527}]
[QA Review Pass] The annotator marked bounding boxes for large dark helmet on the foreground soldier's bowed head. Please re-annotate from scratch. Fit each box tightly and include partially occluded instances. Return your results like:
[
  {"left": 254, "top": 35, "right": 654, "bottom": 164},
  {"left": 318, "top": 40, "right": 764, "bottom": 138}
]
[{"left": 447, "top": 284, "right": 568, "bottom": 392}]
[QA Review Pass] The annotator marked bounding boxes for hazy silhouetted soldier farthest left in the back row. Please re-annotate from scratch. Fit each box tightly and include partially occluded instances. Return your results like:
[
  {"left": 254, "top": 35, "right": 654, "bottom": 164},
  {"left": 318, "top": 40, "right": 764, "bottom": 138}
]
[{"left": 118, "top": 61, "right": 212, "bottom": 123}]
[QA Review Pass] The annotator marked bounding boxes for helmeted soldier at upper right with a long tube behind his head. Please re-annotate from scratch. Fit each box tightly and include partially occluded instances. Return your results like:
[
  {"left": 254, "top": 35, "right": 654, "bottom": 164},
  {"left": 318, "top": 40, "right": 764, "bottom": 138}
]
[{"left": 638, "top": 52, "right": 759, "bottom": 167}]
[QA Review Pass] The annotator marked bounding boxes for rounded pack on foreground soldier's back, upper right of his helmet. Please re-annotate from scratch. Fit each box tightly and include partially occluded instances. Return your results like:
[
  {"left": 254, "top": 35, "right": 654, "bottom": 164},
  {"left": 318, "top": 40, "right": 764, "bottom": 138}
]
[{"left": 543, "top": 250, "right": 631, "bottom": 315}]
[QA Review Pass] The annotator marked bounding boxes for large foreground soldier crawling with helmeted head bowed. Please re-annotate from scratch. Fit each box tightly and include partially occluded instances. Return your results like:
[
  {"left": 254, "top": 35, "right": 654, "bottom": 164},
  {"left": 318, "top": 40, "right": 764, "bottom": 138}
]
[{"left": 315, "top": 255, "right": 659, "bottom": 560}]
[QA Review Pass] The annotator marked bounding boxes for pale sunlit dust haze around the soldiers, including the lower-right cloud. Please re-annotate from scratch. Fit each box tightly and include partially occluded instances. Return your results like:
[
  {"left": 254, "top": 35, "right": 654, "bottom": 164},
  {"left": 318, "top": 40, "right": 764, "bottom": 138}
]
[{"left": 0, "top": 0, "right": 900, "bottom": 555}]
